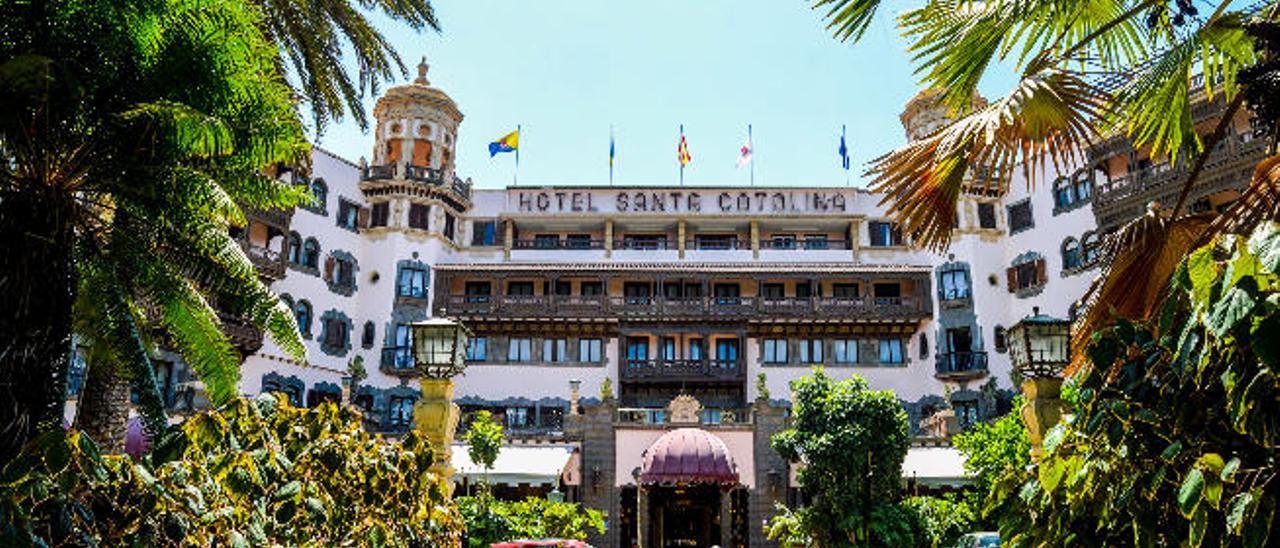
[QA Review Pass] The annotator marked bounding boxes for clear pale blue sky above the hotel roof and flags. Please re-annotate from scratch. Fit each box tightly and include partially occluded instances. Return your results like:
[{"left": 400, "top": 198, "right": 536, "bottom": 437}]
[{"left": 320, "top": 0, "right": 1011, "bottom": 188}]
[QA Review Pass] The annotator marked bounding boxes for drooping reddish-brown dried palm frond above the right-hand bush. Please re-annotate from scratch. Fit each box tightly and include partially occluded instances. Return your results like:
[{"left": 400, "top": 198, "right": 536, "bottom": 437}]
[{"left": 1066, "top": 205, "right": 1213, "bottom": 374}]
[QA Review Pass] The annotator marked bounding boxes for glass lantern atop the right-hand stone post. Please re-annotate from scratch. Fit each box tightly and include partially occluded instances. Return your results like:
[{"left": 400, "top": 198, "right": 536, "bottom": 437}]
[{"left": 1009, "top": 306, "right": 1071, "bottom": 378}]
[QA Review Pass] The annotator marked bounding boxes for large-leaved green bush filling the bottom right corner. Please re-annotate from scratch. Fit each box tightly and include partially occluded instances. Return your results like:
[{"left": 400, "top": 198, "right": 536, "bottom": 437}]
[{"left": 988, "top": 223, "right": 1280, "bottom": 547}]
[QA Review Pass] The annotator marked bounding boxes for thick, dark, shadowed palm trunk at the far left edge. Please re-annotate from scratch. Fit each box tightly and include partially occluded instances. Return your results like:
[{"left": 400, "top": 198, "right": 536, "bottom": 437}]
[{"left": 0, "top": 191, "right": 76, "bottom": 462}]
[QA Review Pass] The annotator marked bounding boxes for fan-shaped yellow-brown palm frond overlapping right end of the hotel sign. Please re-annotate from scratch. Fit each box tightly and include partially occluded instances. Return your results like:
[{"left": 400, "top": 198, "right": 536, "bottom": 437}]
[{"left": 868, "top": 68, "right": 1106, "bottom": 250}]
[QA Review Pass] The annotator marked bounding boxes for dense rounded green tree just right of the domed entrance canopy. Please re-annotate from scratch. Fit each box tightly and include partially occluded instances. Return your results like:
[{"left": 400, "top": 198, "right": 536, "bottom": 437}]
[{"left": 767, "top": 369, "right": 914, "bottom": 545}]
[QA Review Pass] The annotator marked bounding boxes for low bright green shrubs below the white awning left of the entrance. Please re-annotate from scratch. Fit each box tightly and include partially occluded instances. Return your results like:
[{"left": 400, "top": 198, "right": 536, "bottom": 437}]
[{"left": 457, "top": 494, "right": 604, "bottom": 548}]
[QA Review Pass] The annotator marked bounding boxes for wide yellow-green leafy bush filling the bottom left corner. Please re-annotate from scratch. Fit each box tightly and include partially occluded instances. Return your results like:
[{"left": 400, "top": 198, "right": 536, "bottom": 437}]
[{"left": 0, "top": 394, "right": 462, "bottom": 545}]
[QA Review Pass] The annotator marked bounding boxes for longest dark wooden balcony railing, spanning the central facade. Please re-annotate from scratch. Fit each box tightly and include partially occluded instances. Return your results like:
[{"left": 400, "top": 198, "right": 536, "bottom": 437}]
[{"left": 438, "top": 294, "right": 928, "bottom": 319}]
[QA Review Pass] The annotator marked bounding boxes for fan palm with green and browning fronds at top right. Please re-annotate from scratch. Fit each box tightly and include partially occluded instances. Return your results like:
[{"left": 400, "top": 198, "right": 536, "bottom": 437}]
[{"left": 814, "top": 0, "right": 1280, "bottom": 356}]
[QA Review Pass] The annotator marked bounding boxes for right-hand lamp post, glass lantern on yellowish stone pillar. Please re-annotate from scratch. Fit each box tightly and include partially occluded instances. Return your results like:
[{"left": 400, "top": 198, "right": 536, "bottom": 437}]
[{"left": 1009, "top": 306, "right": 1071, "bottom": 462}]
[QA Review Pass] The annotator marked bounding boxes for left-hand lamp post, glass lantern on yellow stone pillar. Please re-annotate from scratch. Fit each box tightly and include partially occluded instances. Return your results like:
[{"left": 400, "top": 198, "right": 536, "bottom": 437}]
[{"left": 410, "top": 318, "right": 471, "bottom": 494}]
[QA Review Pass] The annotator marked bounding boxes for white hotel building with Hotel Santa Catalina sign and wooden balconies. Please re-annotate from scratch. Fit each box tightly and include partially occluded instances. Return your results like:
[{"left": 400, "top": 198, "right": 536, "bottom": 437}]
[{"left": 129, "top": 57, "right": 1252, "bottom": 547}]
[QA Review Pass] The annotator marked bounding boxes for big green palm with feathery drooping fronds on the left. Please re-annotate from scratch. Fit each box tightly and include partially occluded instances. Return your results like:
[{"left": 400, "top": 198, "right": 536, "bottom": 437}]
[{"left": 0, "top": 0, "right": 308, "bottom": 458}]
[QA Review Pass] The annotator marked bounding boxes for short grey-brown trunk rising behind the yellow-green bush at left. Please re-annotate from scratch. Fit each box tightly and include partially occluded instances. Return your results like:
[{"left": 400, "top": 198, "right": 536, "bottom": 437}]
[{"left": 76, "top": 360, "right": 129, "bottom": 453}]
